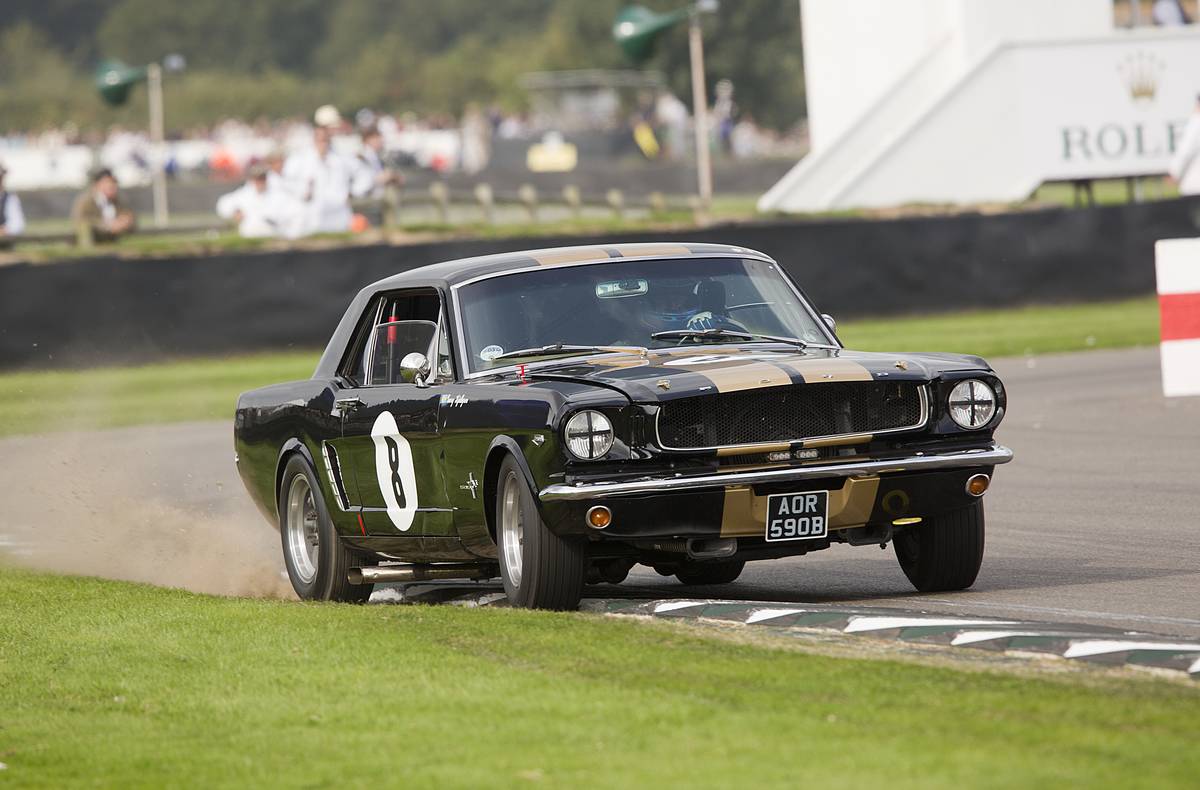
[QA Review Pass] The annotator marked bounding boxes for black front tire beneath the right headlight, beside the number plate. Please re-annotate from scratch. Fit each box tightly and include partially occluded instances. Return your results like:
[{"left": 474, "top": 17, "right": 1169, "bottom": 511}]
[{"left": 892, "top": 502, "right": 984, "bottom": 592}]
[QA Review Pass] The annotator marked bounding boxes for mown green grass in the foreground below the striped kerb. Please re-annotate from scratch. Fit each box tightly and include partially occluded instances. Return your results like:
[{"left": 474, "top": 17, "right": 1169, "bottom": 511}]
[{"left": 0, "top": 569, "right": 1200, "bottom": 790}]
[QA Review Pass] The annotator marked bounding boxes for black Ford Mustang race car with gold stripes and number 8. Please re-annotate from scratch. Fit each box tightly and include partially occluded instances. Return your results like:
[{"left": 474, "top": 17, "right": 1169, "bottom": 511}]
[{"left": 235, "top": 244, "right": 1012, "bottom": 609}]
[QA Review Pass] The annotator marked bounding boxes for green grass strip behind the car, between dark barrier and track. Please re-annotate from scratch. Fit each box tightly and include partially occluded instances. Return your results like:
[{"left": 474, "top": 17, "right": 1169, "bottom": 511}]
[{"left": 0, "top": 298, "right": 1158, "bottom": 436}]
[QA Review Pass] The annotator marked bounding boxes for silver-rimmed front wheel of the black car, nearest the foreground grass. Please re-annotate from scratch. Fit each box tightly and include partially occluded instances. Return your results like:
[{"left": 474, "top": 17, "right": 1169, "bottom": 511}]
[{"left": 494, "top": 456, "right": 588, "bottom": 611}]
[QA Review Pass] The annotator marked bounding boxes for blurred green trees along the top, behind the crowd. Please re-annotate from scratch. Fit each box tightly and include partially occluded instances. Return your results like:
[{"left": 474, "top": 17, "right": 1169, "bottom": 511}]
[{"left": 0, "top": 0, "right": 804, "bottom": 131}]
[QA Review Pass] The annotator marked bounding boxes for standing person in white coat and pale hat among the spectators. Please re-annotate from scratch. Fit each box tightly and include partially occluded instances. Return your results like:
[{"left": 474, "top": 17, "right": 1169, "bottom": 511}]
[{"left": 283, "top": 126, "right": 360, "bottom": 233}]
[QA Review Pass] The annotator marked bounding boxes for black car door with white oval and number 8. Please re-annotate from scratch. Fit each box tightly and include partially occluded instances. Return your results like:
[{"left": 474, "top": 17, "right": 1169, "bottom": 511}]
[{"left": 337, "top": 289, "right": 452, "bottom": 537}]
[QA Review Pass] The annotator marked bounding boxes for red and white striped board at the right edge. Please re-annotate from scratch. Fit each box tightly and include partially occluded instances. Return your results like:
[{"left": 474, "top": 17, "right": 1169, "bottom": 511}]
[{"left": 1154, "top": 239, "right": 1200, "bottom": 397}]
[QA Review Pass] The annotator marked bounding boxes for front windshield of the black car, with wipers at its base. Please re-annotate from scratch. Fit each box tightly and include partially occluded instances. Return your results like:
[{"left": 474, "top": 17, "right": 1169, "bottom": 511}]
[{"left": 458, "top": 258, "right": 833, "bottom": 372}]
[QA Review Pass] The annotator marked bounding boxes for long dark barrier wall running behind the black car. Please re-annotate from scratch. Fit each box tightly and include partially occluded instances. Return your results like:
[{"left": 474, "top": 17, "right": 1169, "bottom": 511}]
[{"left": 0, "top": 198, "right": 1200, "bottom": 369}]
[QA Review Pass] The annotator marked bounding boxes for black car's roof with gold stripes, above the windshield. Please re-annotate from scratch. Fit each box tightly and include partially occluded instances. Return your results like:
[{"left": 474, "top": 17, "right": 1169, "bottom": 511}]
[{"left": 367, "top": 241, "right": 770, "bottom": 291}]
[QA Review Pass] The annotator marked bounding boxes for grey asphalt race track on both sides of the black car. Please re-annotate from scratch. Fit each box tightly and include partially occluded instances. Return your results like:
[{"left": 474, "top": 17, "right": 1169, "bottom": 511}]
[{"left": 0, "top": 349, "right": 1200, "bottom": 638}]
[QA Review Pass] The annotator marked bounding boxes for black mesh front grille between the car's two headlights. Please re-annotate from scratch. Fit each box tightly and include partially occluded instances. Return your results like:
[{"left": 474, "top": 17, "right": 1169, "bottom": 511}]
[{"left": 659, "top": 382, "right": 925, "bottom": 450}]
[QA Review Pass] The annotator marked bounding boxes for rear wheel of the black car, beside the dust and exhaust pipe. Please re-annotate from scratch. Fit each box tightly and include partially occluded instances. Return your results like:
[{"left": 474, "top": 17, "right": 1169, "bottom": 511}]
[{"left": 278, "top": 454, "right": 373, "bottom": 603}]
